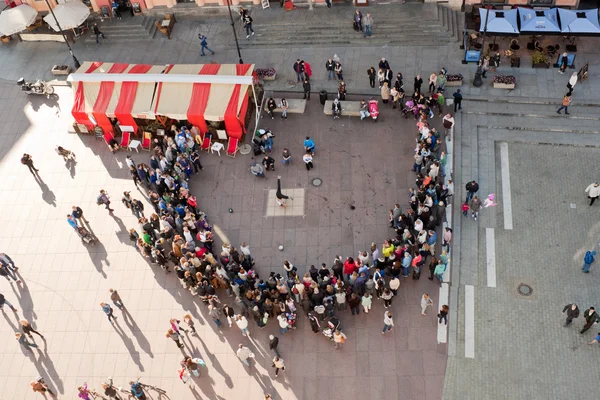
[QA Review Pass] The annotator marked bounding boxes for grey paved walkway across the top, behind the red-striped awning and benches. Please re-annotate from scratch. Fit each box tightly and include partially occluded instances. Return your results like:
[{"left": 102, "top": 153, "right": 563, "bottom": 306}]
[{"left": 0, "top": 4, "right": 600, "bottom": 104}]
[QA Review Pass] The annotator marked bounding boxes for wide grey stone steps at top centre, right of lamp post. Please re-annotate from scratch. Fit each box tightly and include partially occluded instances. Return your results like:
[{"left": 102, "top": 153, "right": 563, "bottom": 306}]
[{"left": 230, "top": 3, "right": 462, "bottom": 48}]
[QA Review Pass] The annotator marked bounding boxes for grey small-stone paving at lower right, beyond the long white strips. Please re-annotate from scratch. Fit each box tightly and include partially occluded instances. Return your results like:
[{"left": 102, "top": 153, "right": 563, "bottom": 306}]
[{"left": 444, "top": 143, "right": 600, "bottom": 399}]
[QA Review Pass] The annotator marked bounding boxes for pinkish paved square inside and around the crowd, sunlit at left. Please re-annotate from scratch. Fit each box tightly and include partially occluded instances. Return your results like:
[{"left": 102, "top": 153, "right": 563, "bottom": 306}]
[{"left": 0, "top": 84, "right": 446, "bottom": 400}]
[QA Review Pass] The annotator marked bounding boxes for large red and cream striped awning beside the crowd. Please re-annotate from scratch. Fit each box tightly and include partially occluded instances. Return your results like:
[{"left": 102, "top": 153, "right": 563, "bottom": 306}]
[{"left": 68, "top": 62, "right": 254, "bottom": 138}]
